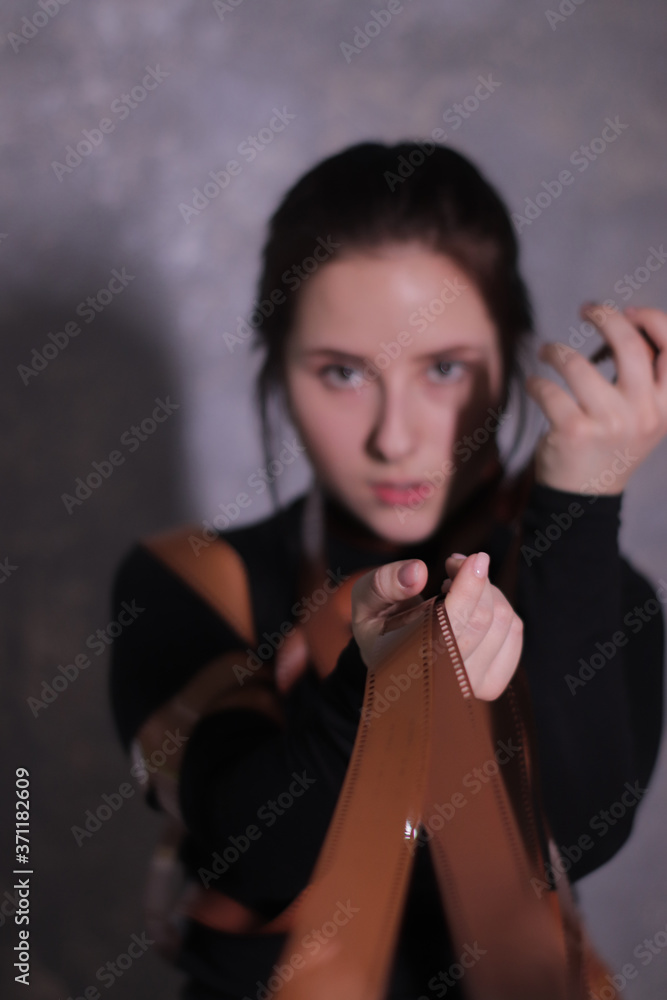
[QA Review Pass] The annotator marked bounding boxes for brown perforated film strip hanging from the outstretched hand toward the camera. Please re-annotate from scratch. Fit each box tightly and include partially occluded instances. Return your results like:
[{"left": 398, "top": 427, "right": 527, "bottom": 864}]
[{"left": 278, "top": 596, "right": 586, "bottom": 1000}]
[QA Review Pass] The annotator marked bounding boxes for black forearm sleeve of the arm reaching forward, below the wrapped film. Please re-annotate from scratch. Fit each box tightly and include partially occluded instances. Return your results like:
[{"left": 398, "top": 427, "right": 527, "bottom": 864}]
[{"left": 180, "top": 639, "right": 366, "bottom": 916}]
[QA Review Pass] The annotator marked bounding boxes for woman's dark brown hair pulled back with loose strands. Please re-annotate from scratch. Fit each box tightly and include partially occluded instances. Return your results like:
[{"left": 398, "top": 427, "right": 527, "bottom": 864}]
[{"left": 252, "top": 142, "right": 533, "bottom": 502}]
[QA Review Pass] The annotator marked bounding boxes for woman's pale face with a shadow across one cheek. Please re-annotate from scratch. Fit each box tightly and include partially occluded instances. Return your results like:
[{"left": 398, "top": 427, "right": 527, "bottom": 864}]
[{"left": 285, "top": 243, "right": 503, "bottom": 543}]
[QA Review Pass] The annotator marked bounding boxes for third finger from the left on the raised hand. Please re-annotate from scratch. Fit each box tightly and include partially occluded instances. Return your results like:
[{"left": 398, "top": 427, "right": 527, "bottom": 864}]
[{"left": 581, "top": 303, "right": 653, "bottom": 399}]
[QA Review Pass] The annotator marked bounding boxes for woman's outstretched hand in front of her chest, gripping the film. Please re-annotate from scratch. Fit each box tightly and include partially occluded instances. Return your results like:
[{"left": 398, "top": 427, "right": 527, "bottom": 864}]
[{"left": 352, "top": 552, "right": 523, "bottom": 701}]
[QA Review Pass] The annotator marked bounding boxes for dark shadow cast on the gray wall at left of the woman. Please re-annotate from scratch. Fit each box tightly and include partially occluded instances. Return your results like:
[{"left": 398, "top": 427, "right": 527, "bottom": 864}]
[{"left": 0, "top": 236, "right": 187, "bottom": 1000}]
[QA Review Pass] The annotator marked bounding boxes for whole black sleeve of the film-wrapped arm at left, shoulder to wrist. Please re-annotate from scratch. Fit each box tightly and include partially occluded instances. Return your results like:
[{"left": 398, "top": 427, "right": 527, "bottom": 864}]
[{"left": 110, "top": 532, "right": 366, "bottom": 914}]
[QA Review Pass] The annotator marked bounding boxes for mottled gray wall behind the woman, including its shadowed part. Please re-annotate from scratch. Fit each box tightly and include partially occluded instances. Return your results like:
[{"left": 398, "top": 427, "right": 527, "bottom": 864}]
[{"left": 0, "top": 0, "right": 667, "bottom": 1000}]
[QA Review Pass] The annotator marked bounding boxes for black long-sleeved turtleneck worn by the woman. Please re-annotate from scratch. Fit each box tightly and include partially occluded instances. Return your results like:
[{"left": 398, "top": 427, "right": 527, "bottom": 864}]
[{"left": 111, "top": 485, "right": 667, "bottom": 1000}]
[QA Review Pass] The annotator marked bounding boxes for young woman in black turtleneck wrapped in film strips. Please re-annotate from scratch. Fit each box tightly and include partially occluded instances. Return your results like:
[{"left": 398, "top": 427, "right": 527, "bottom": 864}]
[{"left": 112, "top": 143, "right": 667, "bottom": 1000}]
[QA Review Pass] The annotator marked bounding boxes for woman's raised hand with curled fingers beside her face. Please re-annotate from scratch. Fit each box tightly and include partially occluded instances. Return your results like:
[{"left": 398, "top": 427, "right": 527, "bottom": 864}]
[{"left": 526, "top": 305, "right": 667, "bottom": 494}]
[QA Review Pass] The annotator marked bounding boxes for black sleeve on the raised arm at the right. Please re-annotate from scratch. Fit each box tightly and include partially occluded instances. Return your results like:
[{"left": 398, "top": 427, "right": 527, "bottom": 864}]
[{"left": 516, "top": 484, "right": 667, "bottom": 879}]
